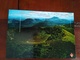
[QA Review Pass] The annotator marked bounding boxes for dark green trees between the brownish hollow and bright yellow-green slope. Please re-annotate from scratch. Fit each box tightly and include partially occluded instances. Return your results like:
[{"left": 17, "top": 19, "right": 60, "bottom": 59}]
[{"left": 45, "top": 26, "right": 64, "bottom": 40}]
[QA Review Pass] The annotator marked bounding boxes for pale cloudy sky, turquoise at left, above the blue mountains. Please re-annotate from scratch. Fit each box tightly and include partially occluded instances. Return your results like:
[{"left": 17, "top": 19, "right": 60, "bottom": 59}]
[{"left": 8, "top": 9, "right": 74, "bottom": 20}]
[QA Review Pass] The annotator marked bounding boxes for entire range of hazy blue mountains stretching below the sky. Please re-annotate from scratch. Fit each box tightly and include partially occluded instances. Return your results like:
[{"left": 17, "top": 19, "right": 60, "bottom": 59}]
[{"left": 9, "top": 17, "right": 73, "bottom": 27}]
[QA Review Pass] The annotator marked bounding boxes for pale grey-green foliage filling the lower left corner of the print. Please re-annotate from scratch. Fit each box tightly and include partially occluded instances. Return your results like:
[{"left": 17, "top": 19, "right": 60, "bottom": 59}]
[{"left": 6, "top": 28, "right": 33, "bottom": 58}]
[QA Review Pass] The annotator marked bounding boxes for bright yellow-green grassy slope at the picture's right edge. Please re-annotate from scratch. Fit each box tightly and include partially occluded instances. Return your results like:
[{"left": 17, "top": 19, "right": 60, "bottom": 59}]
[{"left": 62, "top": 29, "right": 75, "bottom": 44}]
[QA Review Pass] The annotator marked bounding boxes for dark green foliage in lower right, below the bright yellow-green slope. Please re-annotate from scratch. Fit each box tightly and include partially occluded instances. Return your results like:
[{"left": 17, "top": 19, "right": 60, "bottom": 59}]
[{"left": 40, "top": 41, "right": 75, "bottom": 58}]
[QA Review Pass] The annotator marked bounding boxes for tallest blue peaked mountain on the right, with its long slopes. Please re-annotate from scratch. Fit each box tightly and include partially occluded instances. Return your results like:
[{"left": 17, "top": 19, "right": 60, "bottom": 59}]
[{"left": 32, "top": 17, "right": 73, "bottom": 27}]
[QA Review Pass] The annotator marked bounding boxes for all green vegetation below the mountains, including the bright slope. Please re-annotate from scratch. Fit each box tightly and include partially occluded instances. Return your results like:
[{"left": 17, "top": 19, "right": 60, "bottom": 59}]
[{"left": 7, "top": 25, "right": 75, "bottom": 58}]
